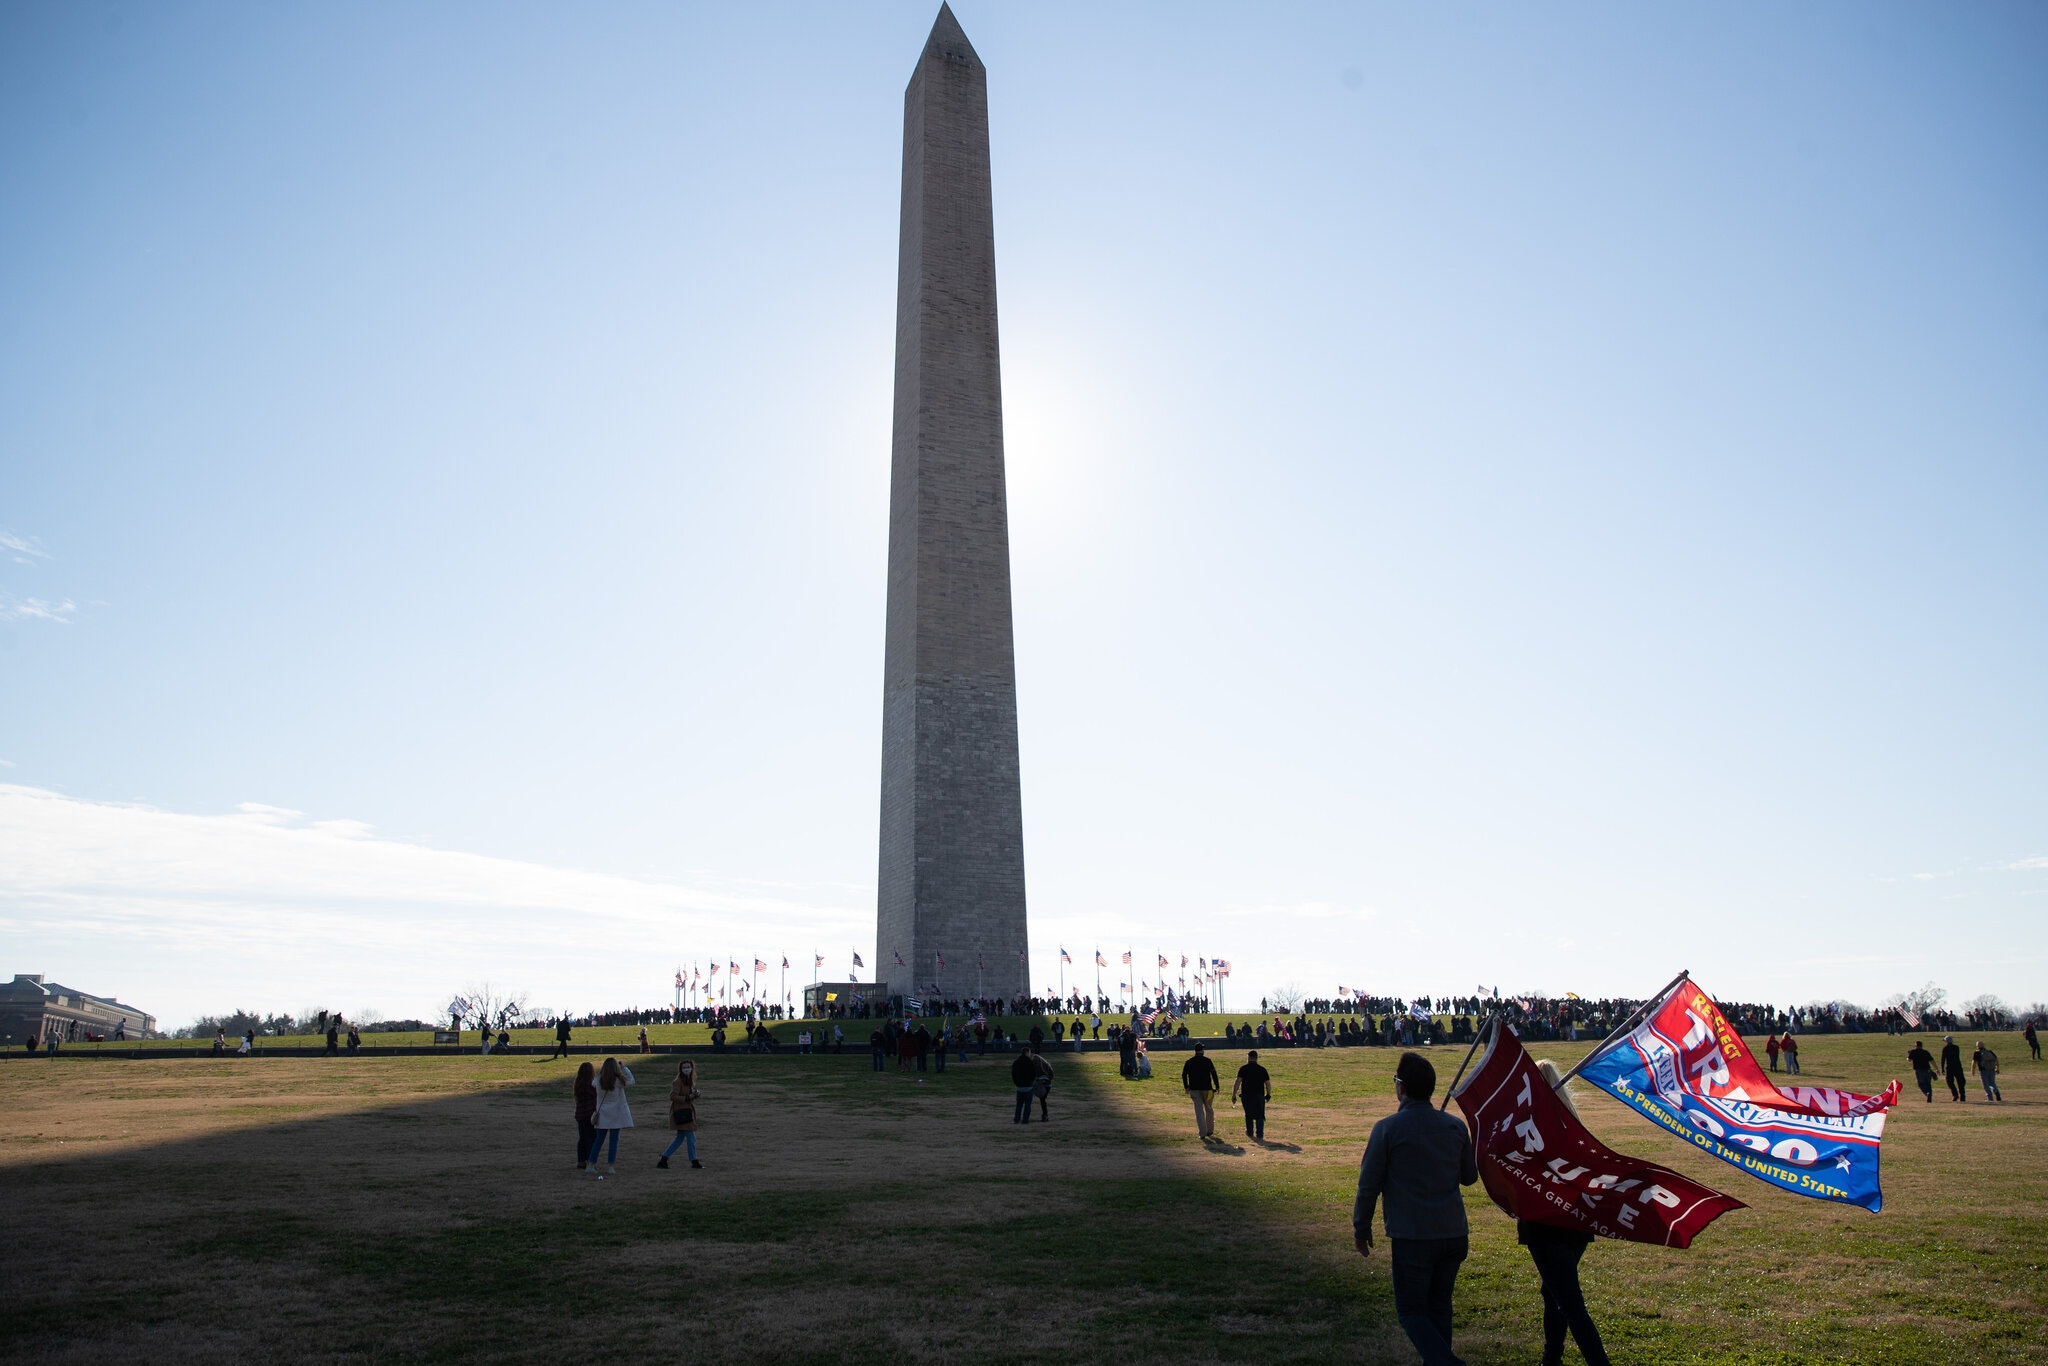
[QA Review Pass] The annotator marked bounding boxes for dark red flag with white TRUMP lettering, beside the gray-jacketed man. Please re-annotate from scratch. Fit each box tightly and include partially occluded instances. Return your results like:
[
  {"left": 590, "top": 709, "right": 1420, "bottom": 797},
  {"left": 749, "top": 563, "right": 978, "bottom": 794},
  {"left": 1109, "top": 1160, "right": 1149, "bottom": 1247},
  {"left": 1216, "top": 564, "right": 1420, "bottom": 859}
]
[{"left": 1450, "top": 1020, "right": 1743, "bottom": 1247}]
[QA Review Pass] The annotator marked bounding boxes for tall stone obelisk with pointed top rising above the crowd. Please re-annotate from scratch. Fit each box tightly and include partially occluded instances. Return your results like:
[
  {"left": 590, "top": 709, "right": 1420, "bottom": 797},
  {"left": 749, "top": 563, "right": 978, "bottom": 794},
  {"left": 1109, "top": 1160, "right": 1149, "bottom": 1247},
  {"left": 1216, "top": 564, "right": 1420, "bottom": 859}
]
[{"left": 874, "top": 6, "right": 1028, "bottom": 1011}]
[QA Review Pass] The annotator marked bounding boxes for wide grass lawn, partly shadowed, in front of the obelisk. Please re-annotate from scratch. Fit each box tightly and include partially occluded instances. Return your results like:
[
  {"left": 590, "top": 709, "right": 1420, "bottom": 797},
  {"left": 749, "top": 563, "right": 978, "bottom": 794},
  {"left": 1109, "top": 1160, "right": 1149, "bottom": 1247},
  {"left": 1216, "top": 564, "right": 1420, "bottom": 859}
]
[{"left": 0, "top": 1032, "right": 2048, "bottom": 1364}]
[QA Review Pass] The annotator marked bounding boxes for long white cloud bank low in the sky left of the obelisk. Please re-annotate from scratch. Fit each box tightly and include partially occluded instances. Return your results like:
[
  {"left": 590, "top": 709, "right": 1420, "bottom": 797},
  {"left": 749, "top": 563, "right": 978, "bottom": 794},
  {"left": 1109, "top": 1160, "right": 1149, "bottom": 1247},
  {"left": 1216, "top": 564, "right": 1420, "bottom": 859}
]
[{"left": 0, "top": 784, "right": 874, "bottom": 1024}]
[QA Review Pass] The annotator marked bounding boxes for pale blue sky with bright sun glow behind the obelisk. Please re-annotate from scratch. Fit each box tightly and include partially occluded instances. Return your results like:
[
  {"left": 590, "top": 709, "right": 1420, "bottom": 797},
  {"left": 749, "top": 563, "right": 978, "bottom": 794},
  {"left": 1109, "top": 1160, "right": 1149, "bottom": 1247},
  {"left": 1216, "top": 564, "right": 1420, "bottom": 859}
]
[{"left": 0, "top": 2, "right": 2048, "bottom": 1022}]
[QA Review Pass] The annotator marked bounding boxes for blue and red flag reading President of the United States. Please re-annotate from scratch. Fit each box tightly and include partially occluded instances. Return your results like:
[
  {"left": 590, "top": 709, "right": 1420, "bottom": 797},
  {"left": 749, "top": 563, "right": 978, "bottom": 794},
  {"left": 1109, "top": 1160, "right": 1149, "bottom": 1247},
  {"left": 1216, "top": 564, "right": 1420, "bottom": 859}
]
[{"left": 1579, "top": 977, "right": 1898, "bottom": 1210}]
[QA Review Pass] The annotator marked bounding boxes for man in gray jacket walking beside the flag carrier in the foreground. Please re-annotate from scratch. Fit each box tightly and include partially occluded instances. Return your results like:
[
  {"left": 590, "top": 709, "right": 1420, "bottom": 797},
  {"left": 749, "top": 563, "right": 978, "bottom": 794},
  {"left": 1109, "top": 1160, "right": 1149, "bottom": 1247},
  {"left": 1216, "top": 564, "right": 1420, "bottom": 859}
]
[{"left": 1352, "top": 1053, "right": 1479, "bottom": 1366}]
